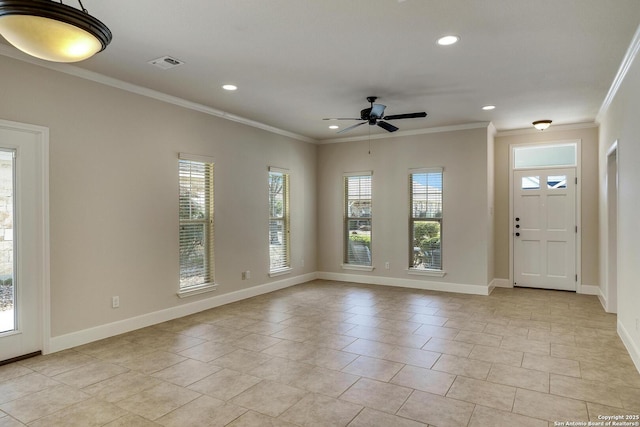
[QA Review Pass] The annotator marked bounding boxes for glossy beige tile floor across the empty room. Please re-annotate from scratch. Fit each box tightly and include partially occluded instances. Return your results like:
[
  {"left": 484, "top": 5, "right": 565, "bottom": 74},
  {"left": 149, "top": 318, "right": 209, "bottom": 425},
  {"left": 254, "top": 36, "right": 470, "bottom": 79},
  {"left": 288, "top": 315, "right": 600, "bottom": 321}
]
[{"left": 0, "top": 280, "right": 640, "bottom": 427}]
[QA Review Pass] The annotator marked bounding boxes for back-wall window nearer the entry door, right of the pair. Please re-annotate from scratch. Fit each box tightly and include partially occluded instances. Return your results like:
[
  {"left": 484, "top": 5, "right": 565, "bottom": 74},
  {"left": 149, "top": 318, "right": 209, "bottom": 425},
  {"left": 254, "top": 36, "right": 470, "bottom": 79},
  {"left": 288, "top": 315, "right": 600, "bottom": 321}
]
[{"left": 409, "top": 168, "right": 442, "bottom": 270}]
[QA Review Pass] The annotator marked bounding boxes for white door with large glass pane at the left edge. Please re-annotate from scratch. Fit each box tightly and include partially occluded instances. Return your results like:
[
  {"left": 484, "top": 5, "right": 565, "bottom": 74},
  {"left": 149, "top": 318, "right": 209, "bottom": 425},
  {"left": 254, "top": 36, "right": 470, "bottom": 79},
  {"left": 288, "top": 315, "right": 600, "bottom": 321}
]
[{"left": 0, "top": 121, "right": 45, "bottom": 362}]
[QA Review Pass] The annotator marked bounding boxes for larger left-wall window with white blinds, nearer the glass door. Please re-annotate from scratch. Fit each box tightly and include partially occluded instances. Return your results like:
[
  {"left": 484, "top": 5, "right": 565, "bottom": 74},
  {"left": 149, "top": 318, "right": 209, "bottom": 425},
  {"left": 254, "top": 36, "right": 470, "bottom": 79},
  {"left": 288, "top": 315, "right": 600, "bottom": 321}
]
[{"left": 178, "top": 153, "right": 214, "bottom": 296}]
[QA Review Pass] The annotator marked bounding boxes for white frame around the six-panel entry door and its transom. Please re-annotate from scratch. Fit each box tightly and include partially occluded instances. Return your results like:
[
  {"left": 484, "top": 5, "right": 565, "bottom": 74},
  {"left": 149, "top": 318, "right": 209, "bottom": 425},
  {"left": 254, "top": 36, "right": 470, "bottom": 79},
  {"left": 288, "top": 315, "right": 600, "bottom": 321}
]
[{"left": 508, "top": 139, "right": 591, "bottom": 294}]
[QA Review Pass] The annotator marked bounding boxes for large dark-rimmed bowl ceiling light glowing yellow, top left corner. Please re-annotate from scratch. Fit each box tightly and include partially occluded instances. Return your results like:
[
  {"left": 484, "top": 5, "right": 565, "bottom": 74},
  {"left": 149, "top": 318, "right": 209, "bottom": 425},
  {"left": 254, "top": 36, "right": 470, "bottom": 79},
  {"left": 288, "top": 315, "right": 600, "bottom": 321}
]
[{"left": 0, "top": 0, "right": 112, "bottom": 62}]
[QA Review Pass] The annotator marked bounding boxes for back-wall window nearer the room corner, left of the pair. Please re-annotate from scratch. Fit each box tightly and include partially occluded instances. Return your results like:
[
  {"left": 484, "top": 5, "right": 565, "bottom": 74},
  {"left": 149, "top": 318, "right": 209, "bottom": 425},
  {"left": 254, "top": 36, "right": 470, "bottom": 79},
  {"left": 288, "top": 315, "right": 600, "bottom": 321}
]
[{"left": 344, "top": 172, "right": 371, "bottom": 266}]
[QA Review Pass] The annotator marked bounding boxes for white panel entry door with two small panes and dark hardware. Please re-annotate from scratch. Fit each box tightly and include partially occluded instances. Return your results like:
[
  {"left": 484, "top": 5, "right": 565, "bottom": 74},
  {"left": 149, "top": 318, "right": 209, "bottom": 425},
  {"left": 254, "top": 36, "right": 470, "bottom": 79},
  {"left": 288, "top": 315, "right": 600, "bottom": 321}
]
[{"left": 513, "top": 168, "right": 577, "bottom": 291}]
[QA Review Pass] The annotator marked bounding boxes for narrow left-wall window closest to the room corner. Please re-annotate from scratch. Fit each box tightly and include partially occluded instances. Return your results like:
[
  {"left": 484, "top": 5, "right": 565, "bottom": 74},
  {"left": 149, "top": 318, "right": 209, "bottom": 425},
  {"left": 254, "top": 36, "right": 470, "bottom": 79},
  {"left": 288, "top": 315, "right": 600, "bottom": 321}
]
[{"left": 269, "top": 167, "right": 291, "bottom": 274}]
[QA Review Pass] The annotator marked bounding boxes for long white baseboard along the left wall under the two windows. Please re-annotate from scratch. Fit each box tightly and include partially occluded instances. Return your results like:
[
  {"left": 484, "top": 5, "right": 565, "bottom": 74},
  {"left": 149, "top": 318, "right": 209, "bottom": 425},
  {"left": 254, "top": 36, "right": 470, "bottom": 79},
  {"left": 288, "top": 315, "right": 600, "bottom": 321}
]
[{"left": 48, "top": 272, "right": 318, "bottom": 353}]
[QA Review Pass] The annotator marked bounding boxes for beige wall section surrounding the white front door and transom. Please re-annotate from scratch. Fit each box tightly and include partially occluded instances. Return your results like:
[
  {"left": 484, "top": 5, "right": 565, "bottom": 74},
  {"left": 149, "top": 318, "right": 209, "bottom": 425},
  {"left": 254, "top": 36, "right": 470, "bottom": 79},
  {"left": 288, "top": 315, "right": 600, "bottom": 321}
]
[{"left": 494, "top": 126, "right": 600, "bottom": 286}]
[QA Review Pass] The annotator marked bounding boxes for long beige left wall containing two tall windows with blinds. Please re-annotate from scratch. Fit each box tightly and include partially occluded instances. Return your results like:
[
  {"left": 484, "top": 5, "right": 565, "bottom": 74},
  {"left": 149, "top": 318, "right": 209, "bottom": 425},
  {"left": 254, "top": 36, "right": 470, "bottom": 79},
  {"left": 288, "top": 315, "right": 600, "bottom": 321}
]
[{"left": 0, "top": 57, "right": 317, "bottom": 337}]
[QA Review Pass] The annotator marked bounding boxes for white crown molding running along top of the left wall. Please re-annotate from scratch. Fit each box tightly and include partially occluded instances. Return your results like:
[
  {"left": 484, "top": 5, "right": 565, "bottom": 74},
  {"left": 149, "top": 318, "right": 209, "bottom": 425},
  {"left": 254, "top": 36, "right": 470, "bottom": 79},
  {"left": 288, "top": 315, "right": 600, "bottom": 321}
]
[{"left": 0, "top": 43, "right": 317, "bottom": 143}]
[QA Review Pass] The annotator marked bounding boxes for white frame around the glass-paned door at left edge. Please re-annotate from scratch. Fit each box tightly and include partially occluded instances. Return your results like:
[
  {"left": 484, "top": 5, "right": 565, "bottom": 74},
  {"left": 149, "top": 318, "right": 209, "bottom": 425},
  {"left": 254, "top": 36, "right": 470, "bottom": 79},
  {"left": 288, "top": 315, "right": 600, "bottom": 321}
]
[{"left": 0, "top": 119, "right": 51, "bottom": 354}]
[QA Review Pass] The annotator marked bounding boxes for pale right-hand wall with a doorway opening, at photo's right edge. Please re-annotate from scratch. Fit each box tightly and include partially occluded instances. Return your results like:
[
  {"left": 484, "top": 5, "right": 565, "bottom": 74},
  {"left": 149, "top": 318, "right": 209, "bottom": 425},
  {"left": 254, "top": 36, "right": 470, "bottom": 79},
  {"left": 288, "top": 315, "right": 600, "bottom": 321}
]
[{"left": 599, "top": 46, "right": 640, "bottom": 370}]
